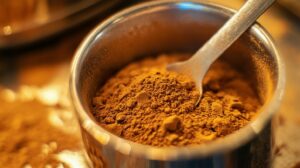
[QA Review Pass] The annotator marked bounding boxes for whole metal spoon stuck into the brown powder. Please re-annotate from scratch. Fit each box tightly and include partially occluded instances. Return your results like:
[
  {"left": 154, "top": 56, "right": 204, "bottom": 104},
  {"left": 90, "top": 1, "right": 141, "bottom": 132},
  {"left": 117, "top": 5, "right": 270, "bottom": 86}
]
[{"left": 167, "top": 0, "right": 275, "bottom": 105}]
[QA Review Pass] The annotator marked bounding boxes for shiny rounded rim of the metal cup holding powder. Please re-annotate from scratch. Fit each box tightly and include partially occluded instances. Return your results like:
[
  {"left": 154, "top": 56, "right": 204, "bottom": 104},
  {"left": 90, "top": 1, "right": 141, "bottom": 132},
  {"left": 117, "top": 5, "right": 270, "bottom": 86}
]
[{"left": 69, "top": 0, "right": 285, "bottom": 160}]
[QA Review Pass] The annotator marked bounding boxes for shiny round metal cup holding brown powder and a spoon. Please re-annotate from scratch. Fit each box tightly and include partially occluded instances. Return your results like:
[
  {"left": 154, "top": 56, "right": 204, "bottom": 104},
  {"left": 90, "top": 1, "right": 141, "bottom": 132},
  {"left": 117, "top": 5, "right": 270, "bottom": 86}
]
[{"left": 70, "top": 0, "right": 285, "bottom": 168}]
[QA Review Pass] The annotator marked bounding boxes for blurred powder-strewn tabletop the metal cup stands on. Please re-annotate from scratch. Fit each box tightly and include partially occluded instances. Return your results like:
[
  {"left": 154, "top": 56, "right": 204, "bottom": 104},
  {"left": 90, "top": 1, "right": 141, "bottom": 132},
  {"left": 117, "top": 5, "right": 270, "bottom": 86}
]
[{"left": 0, "top": 0, "right": 300, "bottom": 168}]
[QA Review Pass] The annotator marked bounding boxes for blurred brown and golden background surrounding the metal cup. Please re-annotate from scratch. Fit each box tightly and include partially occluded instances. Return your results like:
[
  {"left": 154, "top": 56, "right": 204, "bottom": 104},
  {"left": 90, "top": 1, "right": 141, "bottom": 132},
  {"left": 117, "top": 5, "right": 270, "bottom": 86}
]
[{"left": 0, "top": 0, "right": 300, "bottom": 168}]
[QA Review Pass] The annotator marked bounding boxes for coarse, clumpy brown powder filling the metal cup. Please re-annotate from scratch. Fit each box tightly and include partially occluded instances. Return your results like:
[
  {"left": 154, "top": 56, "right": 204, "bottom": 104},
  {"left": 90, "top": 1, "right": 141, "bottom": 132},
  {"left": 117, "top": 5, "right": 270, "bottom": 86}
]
[{"left": 93, "top": 54, "right": 261, "bottom": 147}]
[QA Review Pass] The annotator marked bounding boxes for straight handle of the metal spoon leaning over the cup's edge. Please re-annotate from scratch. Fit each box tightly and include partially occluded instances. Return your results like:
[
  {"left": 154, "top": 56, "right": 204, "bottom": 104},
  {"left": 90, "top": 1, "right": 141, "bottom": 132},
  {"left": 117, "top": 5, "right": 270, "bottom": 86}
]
[{"left": 190, "top": 0, "right": 275, "bottom": 81}]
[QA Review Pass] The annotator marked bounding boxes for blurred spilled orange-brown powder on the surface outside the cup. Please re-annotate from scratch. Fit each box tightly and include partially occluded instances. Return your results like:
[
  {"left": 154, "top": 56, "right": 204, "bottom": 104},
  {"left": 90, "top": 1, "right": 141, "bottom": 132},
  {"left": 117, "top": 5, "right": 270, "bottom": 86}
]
[{"left": 0, "top": 99, "right": 81, "bottom": 168}]
